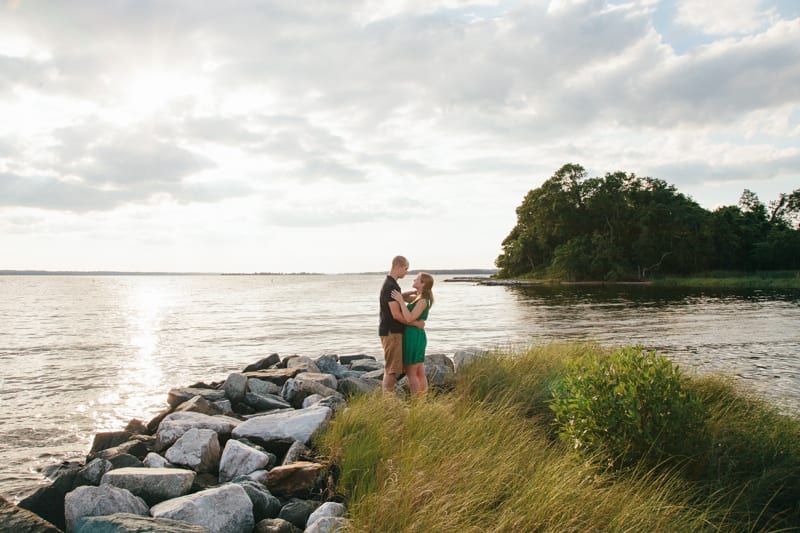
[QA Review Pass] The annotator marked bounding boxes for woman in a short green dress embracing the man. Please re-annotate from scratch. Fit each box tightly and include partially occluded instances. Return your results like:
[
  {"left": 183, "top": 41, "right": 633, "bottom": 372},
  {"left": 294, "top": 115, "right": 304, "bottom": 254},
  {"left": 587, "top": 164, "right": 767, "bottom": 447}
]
[{"left": 392, "top": 272, "right": 433, "bottom": 394}]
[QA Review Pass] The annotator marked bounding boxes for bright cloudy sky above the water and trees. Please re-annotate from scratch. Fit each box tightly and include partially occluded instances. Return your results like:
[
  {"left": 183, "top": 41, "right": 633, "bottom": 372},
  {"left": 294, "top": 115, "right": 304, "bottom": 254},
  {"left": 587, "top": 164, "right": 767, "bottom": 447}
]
[{"left": 0, "top": 0, "right": 800, "bottom": 273}]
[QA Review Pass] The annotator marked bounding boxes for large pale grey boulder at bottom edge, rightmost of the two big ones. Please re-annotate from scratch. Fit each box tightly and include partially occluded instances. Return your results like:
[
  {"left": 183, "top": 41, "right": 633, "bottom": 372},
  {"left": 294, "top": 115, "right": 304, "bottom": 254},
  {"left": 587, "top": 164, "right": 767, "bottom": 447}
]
[{"left": 150, "top": 483, "right": 255, "bottom": 533}]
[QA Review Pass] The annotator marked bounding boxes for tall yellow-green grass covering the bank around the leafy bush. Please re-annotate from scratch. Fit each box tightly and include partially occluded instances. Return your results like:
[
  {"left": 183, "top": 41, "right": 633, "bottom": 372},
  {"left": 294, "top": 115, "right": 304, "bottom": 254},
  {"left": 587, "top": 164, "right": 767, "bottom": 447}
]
[{"left": 318, "top": 345, "right": 800, "bottom": 532}]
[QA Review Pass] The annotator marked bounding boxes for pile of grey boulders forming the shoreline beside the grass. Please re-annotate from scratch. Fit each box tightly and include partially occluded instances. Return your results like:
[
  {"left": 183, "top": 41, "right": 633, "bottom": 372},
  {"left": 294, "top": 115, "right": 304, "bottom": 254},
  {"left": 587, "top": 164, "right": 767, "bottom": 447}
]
[{"left": 0, "top": 351, "right": 462, "bottom": 533}]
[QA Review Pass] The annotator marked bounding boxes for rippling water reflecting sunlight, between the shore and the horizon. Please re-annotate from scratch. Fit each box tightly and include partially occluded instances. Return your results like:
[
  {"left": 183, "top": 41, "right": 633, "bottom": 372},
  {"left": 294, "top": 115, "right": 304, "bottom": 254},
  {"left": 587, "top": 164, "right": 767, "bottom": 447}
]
[{"left": 0, "top": 275, "right": 800, "bottom": 498}]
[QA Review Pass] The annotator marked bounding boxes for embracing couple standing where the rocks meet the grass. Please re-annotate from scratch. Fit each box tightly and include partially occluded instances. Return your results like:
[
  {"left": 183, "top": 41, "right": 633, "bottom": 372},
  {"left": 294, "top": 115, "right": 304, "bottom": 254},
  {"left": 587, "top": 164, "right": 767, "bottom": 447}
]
[{"left": 378, "top": 255, "right": 433, "bottom": 395}]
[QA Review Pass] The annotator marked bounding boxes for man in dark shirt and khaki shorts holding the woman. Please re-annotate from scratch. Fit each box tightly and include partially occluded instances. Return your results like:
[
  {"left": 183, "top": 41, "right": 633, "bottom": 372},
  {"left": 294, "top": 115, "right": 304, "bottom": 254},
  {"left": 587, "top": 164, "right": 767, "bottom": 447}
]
[{"left": 378, "top": 255, "right": 408, "bottom": 394}]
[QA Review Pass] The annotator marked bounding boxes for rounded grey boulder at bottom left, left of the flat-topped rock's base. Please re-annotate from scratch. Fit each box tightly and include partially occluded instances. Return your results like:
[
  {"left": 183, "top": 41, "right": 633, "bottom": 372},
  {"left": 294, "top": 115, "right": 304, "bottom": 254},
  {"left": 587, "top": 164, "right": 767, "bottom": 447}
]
[{"left": 64, "top": 484, "right": 148, "bottom": 531}]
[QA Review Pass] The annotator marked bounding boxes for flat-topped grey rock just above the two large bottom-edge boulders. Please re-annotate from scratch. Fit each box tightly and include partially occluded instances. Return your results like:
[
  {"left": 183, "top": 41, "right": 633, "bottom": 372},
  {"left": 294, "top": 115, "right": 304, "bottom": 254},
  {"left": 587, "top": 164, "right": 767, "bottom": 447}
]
[{"left": 101, "top": 468, "right": 196, "bottom": 505}]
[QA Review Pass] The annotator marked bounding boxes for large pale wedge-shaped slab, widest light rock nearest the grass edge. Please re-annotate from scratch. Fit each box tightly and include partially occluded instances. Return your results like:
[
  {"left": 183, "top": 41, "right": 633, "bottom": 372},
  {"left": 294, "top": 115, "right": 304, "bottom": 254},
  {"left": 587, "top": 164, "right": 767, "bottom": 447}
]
[{"left": 232, "top": 406, "right": 333, "bottom": 444}]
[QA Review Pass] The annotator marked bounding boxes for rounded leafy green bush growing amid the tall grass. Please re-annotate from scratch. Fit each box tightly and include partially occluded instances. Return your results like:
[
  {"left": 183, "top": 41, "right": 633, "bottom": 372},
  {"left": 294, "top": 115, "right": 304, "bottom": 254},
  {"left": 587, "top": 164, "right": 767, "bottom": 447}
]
[{"left": 551, "top": 346, "right": 704, "bottom": 466}]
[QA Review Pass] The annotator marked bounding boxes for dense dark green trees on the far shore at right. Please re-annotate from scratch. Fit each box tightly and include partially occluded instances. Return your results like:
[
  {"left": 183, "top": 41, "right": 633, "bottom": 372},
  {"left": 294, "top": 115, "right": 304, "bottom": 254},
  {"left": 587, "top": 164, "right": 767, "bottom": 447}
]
[{"left": 495, "top": 164, "right": 800, "bottom": 281}]
